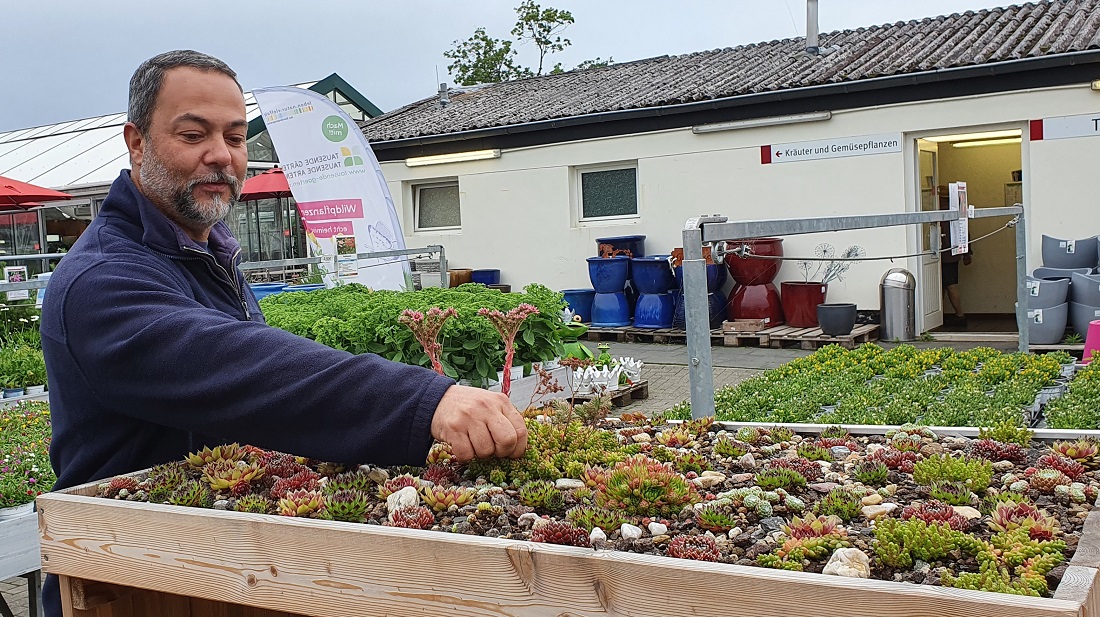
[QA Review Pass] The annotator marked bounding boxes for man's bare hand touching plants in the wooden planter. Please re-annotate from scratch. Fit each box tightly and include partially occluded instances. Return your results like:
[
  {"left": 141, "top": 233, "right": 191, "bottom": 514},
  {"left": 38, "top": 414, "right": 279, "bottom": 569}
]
[{"left": 431, "top": 386, "right": 527, "bottom": 462}]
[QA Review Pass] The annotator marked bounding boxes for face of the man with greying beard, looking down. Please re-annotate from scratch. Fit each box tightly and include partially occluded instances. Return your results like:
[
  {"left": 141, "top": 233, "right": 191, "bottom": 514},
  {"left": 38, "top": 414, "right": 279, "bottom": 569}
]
[{"left": 127, "top": 67, "right": 249, "bottom": 234}]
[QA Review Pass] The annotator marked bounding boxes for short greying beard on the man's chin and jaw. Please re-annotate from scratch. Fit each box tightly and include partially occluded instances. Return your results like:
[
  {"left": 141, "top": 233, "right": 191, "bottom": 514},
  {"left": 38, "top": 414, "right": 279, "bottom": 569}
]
[{"left": 139, "top": 147, "right": 241, "bottom": 229}]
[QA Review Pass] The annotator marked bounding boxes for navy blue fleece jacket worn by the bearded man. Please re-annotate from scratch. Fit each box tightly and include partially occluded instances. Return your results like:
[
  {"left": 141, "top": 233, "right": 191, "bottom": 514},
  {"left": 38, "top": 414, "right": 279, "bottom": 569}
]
[{"left": 42, "top": 170, "right": 454, "bottom": 615}]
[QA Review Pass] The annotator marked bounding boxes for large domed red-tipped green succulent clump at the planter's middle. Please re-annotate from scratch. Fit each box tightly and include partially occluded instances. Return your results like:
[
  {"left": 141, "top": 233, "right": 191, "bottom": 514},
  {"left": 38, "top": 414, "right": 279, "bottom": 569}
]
[{"left": 596, "top": 455, "right": 699, "bottom": 516}]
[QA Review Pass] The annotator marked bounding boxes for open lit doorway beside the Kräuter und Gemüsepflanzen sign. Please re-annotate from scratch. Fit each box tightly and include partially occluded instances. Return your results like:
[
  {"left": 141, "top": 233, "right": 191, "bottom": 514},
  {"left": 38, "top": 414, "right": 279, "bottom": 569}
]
[{"left": 917, "top": 129, "right": 1023, "bottom": 332}]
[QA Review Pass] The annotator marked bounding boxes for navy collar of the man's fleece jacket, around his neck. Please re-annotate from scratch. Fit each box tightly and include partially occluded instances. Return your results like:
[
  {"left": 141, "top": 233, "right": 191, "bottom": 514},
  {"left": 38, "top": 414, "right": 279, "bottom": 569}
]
[{"left": 100, "top": 169, "right": 241, "bottom": 265}]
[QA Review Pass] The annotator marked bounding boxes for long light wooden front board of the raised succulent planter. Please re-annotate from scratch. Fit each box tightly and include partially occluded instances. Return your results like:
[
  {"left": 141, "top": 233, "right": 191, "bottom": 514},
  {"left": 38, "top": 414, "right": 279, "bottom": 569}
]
[{"left": 41, "top": 494, "right": 1081, "bottom": 617}]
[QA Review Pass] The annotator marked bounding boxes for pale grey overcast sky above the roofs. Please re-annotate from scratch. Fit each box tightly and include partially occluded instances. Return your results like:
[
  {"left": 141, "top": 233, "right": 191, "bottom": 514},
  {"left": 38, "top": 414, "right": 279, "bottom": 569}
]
[{"left": 0, "top": 0, "right": 998, "bottom": 131}]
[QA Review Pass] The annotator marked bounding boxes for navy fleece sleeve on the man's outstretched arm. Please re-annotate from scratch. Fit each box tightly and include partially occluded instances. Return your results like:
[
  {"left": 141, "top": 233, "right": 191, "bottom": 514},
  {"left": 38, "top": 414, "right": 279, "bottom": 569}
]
[{"left": 51, "top": 257, "right": 454, "bottom": 464}]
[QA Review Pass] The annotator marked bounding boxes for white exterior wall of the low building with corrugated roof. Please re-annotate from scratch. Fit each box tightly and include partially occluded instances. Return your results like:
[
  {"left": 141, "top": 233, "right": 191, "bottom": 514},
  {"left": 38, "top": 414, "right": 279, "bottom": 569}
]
[{"left": 383, "top": 87, "right": 1100, "bottom": 323}]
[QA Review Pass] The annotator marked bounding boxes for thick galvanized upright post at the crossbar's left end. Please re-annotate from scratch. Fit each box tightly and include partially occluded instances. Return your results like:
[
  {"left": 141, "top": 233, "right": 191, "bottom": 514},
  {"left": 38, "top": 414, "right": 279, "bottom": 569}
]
[{"left": 683, "top": 219, "right": 714, "bottom": 418}]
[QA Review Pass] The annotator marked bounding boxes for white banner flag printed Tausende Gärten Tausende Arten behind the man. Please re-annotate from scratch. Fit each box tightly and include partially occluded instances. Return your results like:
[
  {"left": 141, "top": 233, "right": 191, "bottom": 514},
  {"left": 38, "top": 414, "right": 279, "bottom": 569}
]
[{"left": 252, "top": 87, "right": 413, "bottom": 289}]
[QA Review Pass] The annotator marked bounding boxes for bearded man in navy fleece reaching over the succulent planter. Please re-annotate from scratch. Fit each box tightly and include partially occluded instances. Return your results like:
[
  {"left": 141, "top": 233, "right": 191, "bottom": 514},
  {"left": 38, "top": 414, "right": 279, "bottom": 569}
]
[{"left": 42, "top": 51, "right": 527, "bottom": 617}]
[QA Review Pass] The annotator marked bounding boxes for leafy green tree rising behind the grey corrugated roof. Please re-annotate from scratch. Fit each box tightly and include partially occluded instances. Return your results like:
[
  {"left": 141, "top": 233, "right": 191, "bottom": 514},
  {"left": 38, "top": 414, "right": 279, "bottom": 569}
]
[{"left": 443, "top": 0, "right": 615, "bottom": 86}]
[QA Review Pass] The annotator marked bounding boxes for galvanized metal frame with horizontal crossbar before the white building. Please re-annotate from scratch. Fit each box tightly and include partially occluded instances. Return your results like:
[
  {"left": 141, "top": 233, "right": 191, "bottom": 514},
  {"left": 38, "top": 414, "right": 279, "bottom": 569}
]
[{"left": 683, "top": 205, "right": 1029, "bottom": 418}]
